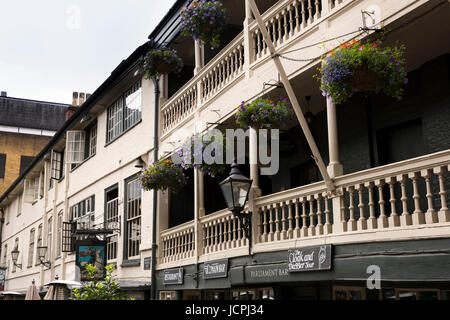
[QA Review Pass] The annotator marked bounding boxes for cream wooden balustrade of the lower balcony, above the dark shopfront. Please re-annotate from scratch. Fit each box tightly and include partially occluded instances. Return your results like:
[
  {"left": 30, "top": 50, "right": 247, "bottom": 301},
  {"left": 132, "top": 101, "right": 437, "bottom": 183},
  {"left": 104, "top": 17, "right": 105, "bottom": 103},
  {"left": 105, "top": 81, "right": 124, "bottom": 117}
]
[{"left": 161, "top": 150, "right": 450, "bottom": 263}]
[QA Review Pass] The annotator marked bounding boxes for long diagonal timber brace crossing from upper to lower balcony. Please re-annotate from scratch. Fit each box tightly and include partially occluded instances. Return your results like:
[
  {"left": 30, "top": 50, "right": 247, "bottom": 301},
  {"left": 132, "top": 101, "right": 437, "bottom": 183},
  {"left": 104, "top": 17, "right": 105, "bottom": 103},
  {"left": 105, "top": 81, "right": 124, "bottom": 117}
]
[{"left": 246, "top": 0, "right": 336, "bottom": 192}]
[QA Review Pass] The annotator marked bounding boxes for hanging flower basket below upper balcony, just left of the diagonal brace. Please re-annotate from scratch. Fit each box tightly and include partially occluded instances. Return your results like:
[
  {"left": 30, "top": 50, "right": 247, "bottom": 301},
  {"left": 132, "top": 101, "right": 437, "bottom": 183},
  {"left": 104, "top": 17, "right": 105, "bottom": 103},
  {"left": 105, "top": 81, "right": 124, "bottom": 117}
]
[{"left": 236, "top": 97, "right": 294, "bottom": 129}]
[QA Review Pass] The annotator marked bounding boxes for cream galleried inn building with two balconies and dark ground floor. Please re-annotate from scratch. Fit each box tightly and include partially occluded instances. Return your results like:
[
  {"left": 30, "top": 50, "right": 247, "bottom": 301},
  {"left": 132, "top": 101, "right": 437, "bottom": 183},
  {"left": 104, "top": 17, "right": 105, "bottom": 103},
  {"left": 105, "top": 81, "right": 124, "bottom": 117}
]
[{"left": 0, "top": 0, "right": 450, "bottom": 300}]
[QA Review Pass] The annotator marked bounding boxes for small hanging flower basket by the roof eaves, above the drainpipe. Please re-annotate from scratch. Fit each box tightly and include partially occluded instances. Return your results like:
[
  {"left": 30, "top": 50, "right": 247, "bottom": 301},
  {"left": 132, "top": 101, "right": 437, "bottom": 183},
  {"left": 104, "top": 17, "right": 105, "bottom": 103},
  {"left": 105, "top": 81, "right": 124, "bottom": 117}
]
[{"left": 144, "top": 49, "right": 183, "bottom": 79}]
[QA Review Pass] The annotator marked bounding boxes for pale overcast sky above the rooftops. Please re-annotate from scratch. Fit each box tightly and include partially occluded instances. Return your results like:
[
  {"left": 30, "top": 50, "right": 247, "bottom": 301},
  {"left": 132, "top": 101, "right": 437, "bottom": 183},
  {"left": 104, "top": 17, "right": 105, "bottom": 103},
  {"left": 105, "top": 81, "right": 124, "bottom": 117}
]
[{"left": 0, "top": 0, "right": 175, "bottom": 103}]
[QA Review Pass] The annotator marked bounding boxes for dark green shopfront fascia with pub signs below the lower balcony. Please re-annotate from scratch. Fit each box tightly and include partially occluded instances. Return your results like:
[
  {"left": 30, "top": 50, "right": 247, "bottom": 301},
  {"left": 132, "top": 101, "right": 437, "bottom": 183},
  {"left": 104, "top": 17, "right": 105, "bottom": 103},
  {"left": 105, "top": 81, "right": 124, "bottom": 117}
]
[{"left": 157, "top": 238, "right": 450, "bottom": 300}]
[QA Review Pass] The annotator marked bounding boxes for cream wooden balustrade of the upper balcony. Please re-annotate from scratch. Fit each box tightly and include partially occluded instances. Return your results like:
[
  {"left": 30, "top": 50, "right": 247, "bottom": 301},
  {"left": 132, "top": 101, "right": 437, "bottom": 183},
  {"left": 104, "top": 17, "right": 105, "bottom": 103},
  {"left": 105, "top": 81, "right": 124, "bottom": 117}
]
[{"left": 160, "top": 0, "right": 352, "bottom": 137}]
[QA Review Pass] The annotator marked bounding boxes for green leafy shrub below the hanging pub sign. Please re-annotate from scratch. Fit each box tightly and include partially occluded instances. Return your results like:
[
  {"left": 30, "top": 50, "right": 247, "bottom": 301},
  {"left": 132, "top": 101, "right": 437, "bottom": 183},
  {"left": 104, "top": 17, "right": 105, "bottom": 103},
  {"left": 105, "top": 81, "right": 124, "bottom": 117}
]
[{"left": 72, "top": 264, "right": 134, "bottom": 300}]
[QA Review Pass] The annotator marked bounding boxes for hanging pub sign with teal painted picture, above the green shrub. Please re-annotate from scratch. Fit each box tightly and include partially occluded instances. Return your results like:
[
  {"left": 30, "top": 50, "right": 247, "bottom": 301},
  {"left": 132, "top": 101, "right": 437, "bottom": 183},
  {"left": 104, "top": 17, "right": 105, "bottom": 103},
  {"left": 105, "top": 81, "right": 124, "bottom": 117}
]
[{"left": 76, "top": 239, "right": 106, "bottom": 281}]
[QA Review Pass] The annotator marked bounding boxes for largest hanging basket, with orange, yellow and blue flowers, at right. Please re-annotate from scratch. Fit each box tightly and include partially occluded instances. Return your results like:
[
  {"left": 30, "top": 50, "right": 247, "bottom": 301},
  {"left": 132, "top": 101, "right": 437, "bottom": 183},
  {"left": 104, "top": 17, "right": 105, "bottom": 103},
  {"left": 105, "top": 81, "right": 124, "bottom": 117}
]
[{"left": 316, "top": 41, "right": 408, "bottom": 104}]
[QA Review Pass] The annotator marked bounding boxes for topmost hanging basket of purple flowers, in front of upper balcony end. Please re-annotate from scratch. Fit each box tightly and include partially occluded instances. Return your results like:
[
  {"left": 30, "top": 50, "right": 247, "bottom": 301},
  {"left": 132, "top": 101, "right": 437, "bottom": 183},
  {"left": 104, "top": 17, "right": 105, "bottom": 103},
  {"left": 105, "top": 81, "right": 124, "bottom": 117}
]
[{"left": 181, "top": 0, "right": 226, "bottom": 48}]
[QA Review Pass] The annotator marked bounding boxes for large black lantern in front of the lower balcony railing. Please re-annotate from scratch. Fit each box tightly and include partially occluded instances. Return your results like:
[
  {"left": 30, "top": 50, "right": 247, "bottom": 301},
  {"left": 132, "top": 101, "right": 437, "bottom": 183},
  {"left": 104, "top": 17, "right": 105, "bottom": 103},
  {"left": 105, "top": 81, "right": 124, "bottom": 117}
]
[{"left": 220, "top": 163, "right": 253, "bottom": 253}]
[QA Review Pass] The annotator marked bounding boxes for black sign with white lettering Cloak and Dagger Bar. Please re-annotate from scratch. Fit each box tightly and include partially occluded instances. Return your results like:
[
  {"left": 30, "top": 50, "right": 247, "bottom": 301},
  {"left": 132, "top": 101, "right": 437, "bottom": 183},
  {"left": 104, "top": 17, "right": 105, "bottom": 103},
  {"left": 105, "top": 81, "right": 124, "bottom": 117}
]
[{"left": 288, "top": 245, "right": 331, "bottom": 272}]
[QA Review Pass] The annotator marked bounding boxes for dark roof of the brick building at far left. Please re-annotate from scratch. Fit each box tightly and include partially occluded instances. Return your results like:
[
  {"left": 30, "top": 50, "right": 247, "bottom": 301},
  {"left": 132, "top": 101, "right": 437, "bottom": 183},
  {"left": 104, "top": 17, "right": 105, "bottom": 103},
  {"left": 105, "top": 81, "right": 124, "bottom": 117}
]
[{"left": 0, "top": 97, "right": 69, "bottom": 131}]
